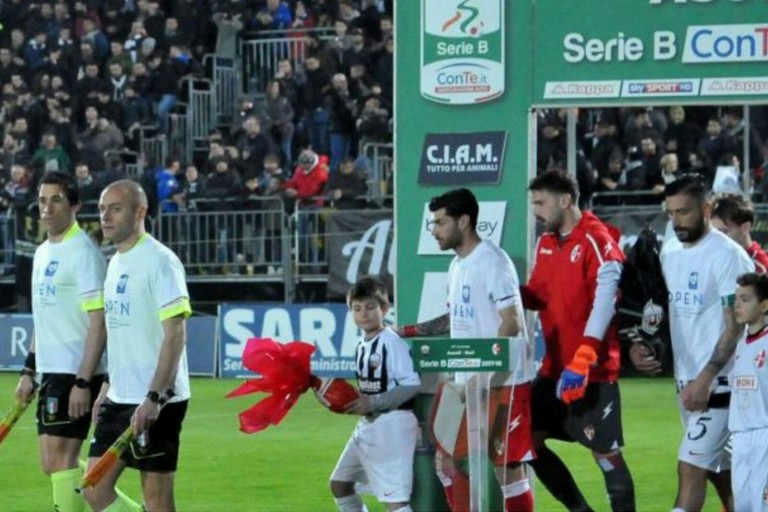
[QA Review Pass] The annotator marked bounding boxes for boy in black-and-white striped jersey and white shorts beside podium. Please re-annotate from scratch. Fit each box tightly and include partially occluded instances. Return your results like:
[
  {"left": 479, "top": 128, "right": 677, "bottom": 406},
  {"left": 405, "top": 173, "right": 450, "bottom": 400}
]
[{"left": 331, "top": 276, "right": 421, "bottom": 512}]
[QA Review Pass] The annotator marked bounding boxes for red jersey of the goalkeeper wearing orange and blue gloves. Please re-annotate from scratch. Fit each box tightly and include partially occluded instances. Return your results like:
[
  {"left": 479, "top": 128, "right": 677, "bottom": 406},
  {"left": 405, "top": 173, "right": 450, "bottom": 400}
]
[{"left": 523, "top": 212, "right": 624, "bottom": 382}]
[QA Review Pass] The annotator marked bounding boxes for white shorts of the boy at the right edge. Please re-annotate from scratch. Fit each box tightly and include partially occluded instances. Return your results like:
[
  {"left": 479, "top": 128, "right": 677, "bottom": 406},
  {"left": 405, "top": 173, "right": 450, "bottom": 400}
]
[{"left": 731, "top": 428, "right": 768, "bottom": 512}]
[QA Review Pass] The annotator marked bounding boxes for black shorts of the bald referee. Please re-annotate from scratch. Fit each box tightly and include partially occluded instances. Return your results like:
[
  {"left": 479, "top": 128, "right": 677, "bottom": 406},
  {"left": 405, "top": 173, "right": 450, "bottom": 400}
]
[{"left": 88, "top": 400, "right": 189, "bottom": 473}]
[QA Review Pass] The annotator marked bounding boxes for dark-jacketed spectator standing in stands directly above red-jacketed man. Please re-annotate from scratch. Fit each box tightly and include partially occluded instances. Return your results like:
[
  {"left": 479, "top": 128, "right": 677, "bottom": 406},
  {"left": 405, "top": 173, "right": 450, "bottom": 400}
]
[{"left": 299, "top": 54, "right": 331, "bottom": 154}]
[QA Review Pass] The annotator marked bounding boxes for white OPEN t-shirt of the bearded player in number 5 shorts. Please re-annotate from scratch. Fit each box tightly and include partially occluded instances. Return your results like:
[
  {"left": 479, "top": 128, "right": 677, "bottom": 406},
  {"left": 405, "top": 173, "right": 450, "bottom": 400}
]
[{"left": 661, "top": 229, "right": 755, "bottom": 381}]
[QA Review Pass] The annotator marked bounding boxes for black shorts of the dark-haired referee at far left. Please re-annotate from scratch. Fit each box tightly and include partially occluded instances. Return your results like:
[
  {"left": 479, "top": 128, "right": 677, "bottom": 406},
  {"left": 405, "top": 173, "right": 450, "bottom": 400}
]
[{"left": 37, "top": 373, "right": 104, "bottom": 439}]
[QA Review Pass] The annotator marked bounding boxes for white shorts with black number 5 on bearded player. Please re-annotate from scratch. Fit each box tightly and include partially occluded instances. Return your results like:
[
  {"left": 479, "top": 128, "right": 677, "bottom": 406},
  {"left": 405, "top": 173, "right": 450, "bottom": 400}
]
[{"left": 677, "top": 395, "right": 731, "bottom": 472}]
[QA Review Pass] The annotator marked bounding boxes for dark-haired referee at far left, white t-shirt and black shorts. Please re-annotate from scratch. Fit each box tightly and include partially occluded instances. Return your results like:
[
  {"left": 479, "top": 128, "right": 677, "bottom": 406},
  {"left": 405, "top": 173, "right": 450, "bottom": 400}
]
[{"left": 10, "top": 172, "right": 111, "bottom": 512}]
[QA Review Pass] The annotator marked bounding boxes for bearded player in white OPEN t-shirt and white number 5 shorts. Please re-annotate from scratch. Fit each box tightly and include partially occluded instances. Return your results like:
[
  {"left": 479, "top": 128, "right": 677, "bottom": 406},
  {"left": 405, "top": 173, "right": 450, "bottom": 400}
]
[{"left": 630, "top": 175, "right": 755, "bottom": 511}]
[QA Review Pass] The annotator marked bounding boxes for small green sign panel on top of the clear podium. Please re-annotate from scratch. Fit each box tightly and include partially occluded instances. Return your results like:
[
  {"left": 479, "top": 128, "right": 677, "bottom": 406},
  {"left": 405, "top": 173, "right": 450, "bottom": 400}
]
[{"left": 411, "top": 338, "right": 509, "bottom": 373}]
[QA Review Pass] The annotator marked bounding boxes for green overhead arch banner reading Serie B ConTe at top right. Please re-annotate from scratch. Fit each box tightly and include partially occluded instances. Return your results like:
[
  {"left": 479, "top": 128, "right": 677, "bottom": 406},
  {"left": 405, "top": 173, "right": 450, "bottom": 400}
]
[{"left": 532, "top": 0, "right": 768, "bottom": 106}]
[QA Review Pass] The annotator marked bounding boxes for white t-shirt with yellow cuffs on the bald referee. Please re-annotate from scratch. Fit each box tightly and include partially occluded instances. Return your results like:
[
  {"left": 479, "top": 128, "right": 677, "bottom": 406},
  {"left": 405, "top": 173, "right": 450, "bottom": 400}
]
[{"left": 104, "top": 234, "right": 192, "bottom": 404}]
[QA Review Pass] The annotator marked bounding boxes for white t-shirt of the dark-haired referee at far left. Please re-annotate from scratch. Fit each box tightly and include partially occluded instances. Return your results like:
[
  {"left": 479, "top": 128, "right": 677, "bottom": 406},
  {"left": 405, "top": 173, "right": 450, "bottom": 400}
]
[{"left": 32, "top": 223, "right": 107, "bottom": 374}]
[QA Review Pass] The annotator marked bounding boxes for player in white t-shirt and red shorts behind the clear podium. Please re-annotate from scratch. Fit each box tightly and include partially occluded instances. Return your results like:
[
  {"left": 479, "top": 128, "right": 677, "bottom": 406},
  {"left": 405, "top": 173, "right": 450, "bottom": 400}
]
[{"left": 402, "top": 188, "right": 533, "bottom": 511}]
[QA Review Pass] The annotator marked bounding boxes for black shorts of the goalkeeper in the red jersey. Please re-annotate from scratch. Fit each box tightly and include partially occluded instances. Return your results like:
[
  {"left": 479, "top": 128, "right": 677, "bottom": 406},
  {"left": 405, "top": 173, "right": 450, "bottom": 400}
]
[{"left": 531, "top": 378, "right": 624, "bottom": 453}]
